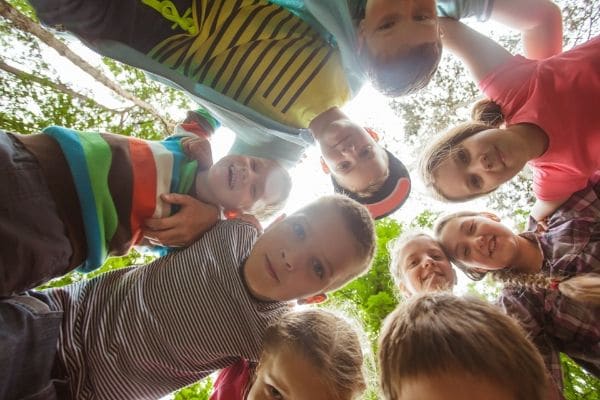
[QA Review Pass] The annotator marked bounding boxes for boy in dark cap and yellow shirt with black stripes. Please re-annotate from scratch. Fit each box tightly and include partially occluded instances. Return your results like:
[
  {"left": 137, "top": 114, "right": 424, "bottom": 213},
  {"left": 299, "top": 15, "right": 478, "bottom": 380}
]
[{"left": 31, "top": 0, "right": 410, "bottom": 217}]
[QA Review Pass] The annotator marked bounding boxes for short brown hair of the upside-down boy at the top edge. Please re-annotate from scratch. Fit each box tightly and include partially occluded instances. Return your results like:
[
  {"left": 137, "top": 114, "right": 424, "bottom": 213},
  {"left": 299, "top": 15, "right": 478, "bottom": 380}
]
[{"left": 364, "top": 39, "right": 442, "bottom": 97}]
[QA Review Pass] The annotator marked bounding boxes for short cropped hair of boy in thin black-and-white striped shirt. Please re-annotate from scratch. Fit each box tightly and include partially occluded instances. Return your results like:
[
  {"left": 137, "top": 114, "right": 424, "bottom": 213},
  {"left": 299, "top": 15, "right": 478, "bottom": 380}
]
[{"left": 304, "top": 194, "right": 376, "bottom": 281}]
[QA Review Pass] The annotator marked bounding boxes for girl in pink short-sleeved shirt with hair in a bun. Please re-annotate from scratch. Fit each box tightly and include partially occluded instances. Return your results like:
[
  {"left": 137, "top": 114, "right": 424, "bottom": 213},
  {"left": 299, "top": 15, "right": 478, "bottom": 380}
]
[{"left": 421, "top": 20, "right": 600, "bottom": 221}]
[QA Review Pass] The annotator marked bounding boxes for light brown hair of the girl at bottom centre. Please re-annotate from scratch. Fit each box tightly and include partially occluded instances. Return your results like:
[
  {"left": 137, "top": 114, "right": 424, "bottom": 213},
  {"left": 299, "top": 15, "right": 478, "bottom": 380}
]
[{"left": 257, "top": 309, "right": 366, "bottom": 400}]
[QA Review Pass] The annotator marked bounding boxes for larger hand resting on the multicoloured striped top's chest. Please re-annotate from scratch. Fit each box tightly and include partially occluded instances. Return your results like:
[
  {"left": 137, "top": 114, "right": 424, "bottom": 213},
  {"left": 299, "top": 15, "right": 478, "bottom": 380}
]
[{"left": 144, "top": 193, "right": 219, "bottom": 247}]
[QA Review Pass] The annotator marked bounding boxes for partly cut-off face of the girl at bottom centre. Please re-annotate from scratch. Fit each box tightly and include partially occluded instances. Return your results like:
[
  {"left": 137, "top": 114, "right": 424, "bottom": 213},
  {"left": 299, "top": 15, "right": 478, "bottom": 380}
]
[{"left": 248, "top": 346, "right": 330, "bottom": 400}]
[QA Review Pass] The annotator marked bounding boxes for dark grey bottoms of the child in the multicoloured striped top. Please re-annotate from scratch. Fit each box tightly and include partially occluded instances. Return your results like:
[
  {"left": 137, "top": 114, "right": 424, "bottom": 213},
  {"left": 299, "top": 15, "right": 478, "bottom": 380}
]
[{"left": 0, "top": 130, "right": 73, "bottom": 297}]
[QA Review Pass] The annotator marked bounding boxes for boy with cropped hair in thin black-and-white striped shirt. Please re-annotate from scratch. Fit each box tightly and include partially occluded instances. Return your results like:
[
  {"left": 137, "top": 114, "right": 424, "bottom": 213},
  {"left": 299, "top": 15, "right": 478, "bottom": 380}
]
[{"left": 0, "top": 196, "right": 375, "bottom": 399}]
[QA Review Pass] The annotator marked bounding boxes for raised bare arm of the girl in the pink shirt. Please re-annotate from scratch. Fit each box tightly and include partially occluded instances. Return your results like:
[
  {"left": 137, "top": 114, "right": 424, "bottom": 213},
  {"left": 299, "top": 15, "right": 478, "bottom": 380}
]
[{"left": 440, "top": 18, "right": 512, "bottom": 82}]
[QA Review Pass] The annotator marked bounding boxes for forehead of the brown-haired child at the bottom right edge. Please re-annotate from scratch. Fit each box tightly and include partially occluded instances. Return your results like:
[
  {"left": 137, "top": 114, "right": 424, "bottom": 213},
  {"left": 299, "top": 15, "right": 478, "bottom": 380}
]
[{"left": 393, "top": 373, "right": 515, "bottom": 400}]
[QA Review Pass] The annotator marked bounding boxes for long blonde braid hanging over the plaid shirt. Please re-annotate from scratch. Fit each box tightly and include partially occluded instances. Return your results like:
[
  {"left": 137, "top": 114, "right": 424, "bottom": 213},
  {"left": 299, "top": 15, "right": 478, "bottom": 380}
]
[{"left": 492, "top": 270, "right": 600, "bottom": 305}]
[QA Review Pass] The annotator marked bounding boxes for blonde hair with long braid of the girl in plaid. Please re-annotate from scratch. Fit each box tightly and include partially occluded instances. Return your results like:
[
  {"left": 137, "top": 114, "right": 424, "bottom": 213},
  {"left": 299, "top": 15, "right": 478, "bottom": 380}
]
[{"left": 433, "top": 211, "right": 600, "bottom": 304}]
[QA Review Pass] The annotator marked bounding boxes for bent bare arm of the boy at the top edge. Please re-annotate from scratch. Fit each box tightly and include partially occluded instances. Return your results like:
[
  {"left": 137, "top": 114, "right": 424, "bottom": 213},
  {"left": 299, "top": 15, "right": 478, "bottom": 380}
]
[{"left": 491, "top": 0, "right": 562, "bottom": 60}]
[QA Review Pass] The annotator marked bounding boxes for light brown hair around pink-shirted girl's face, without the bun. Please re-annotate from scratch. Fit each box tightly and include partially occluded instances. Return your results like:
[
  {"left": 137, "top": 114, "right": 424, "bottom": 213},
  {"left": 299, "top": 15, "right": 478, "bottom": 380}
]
[{"left": 419, "top": 122, "right": 497, "bottom": 202}]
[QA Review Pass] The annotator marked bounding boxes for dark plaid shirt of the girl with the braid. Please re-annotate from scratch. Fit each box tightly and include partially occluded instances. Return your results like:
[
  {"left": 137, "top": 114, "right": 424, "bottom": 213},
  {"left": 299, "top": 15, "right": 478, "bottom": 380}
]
[{"left": 499, "top": 173, "right": 600, "bottom": 391}]
